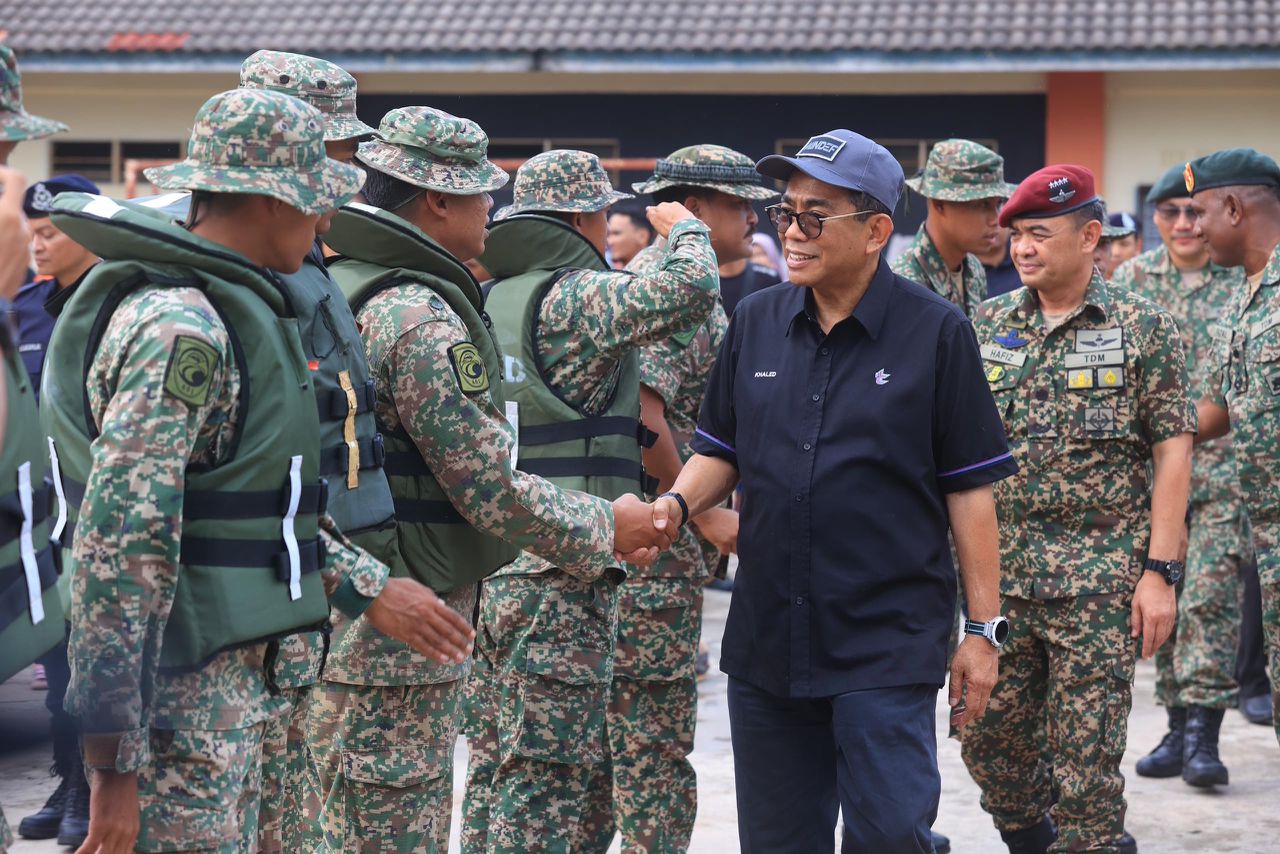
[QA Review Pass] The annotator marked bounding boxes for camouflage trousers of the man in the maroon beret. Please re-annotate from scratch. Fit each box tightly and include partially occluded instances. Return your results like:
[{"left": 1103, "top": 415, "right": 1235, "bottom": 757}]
[{"left": 961, "top": 593, "right": 1138, "bottom": 854}]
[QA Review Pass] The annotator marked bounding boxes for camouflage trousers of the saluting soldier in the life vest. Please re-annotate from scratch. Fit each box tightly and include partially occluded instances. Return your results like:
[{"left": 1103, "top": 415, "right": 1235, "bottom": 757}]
[{"left": 462, "top": 570, "right": 617, "bottom": 853}]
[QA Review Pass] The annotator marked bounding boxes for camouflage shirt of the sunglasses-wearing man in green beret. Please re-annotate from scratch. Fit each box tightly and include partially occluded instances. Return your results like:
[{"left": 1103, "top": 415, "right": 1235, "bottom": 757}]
[{"left": 1111, "top": 245, "right": 1244, "bottom": 510}]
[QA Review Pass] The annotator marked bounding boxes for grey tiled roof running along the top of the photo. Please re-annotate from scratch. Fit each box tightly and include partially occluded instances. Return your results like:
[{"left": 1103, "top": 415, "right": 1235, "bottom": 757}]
[{"left": 0, "top": 0, "right": 1280, "bottom": 64}]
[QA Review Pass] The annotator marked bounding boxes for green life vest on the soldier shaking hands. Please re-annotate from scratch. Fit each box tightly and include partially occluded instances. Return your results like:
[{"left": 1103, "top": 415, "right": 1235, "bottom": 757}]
[{"left": 325, "top": 204, "right": 520, "bottom": 593}]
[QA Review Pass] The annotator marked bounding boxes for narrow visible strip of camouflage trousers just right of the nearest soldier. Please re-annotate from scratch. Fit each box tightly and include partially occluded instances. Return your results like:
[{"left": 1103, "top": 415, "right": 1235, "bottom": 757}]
[{"left": 257, "top": 686, "right": 320, "bottom": 854}]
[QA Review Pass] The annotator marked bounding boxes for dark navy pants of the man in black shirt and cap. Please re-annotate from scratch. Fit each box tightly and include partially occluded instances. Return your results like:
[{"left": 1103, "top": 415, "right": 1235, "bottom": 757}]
[{"left": 728, "top": 677, "right": 942, "bottom": 854}]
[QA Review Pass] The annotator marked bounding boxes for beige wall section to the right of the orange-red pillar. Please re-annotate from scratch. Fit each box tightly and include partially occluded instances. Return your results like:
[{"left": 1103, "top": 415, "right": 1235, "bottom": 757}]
[{"left": 1102, "top": 70, "right": 1280, "bottom": 217}]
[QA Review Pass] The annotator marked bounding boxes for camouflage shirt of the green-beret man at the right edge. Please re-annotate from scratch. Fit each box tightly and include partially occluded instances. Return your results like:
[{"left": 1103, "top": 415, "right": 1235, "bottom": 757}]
[{"left": 1212, "top": 246, "right": 1280, "bottom": 579}]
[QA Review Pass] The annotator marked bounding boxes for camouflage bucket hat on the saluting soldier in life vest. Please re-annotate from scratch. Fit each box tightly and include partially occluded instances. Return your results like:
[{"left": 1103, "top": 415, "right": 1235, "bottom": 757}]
[{"left": 493, "top": 149, "right": 635, "bottom": 222}]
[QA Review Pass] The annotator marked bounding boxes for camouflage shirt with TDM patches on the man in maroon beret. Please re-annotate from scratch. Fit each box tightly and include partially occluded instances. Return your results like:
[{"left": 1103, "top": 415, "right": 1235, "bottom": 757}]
[{"left": 974, "top": 271, "right": 1196, "bottom": 599}]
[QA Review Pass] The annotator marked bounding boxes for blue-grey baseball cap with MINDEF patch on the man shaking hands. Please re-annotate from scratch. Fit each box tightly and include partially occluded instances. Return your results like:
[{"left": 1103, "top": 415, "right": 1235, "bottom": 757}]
[{"left": 755, "top": 128, "right": 904, "bottom": 213}]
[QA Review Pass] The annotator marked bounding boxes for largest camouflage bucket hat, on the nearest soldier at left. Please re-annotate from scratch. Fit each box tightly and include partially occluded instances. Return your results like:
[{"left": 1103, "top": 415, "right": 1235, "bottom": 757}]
[{"left": 145, "top": 88, "right": 365, "bottom": 214}]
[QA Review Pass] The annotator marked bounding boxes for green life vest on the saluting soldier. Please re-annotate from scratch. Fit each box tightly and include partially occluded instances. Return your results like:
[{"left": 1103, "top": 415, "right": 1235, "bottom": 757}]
[{"left": 479, "top": 214, "right": 657, "bottom": 501}]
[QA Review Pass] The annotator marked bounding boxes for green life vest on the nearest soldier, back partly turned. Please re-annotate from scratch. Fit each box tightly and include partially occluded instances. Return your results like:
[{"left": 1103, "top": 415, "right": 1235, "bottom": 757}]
[{"left": 41, "top": 193, "right": 329, "bottom": 668}]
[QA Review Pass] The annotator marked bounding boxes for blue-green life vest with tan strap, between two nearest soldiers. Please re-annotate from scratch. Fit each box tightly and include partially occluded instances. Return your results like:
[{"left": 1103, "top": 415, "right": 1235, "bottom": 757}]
[{"left": 280, "top": 246, "right": 396, "bottom": 536}]
